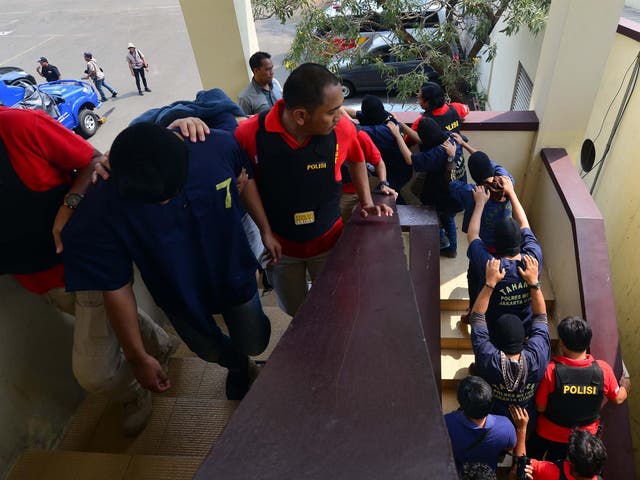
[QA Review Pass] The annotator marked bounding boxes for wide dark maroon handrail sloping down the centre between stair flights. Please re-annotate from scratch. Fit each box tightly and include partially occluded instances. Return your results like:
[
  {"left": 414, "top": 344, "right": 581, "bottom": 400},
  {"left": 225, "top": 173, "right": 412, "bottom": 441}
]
[{"left": 195, "top": 199, "right": 457, "bottom": 480}]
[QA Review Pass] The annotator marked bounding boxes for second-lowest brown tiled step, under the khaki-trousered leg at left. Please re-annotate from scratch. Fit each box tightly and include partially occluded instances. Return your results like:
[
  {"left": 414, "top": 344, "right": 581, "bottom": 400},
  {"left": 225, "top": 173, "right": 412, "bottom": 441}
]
[{"left": 58, "top": 394, "right": 239, "bottom": 458}]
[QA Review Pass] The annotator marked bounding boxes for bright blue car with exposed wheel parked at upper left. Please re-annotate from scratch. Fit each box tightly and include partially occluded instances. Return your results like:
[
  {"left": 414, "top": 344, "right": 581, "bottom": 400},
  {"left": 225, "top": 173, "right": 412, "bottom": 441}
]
[{"left": 0, "top": 76, "right": 104, "bottom": 138}]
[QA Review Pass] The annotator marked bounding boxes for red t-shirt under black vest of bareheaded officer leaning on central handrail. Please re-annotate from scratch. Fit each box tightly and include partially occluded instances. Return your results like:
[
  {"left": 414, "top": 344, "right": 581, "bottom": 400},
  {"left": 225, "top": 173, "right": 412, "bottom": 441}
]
[{"left": 235, "top": 100, "right": 364, "bottom": 258}]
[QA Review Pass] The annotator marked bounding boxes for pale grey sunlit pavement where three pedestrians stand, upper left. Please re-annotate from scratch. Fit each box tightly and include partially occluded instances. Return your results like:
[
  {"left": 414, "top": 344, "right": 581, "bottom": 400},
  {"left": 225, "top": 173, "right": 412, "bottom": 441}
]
[{"left": 0, "top": 0, "right": 418, "bottom": 151}]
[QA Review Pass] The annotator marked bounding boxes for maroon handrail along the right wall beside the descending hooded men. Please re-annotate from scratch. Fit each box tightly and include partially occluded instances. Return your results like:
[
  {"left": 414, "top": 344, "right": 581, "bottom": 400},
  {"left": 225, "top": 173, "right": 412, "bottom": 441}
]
[{"left": 541, "top": 148, "right": 637, "bottom": 479}]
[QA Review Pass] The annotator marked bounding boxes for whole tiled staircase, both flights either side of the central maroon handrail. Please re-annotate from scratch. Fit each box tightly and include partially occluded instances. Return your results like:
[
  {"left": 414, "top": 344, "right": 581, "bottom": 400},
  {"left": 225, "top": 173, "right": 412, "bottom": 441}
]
[{"left": 6, "top": 224, "right": 557, "bottom": 480}]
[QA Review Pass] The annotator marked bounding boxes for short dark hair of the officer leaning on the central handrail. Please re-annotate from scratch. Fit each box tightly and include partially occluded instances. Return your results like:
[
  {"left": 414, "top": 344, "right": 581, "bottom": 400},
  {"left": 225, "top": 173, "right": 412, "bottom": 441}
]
[{"left": 282, "top": 63, "right": 340, "bottom": 113}]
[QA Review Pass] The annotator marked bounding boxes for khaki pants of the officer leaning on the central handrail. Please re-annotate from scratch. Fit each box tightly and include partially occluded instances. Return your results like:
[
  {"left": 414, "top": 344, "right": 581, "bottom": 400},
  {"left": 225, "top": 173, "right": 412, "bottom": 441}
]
[{"left": 272, "top": 250, "right": 331, "bottom": 316}]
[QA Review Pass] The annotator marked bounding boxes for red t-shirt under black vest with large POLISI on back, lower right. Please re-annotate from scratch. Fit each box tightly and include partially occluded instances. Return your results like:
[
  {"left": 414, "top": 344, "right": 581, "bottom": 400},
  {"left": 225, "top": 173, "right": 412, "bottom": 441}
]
[{"left": 536, "top": 355, "right": 620, "bottom": 443}]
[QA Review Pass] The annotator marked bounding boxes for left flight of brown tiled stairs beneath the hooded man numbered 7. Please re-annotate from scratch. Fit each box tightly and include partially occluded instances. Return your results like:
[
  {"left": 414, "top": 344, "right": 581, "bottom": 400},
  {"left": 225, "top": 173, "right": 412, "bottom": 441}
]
[{"left": 6, "top": 292, "right": 291, "bottom": 480}]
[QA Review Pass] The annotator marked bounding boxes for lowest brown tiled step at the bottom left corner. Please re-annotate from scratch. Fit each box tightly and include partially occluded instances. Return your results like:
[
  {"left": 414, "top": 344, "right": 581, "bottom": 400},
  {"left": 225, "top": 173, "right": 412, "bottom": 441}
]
[{"left": 6, "top": 450, "right": 204, "bottom": 480}]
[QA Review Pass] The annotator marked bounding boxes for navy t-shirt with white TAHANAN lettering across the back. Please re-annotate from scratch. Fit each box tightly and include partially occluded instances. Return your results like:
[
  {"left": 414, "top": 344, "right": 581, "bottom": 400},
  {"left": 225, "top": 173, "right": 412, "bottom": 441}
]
[{"left": 467, "top": 228, "right": 542, "bottom": 330}]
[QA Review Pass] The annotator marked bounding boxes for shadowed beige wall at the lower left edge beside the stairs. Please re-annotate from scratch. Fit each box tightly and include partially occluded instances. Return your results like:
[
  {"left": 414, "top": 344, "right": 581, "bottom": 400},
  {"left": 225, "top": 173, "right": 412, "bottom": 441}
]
[{"left": 0, "top": 275, "right": 83, "bottom": 478}]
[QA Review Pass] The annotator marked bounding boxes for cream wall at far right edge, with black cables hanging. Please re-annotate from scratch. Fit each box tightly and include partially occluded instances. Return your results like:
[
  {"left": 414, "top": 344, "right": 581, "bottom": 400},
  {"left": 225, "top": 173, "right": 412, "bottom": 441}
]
[{"left": 585, "top": 31, "right": 640, "bottom": 468}]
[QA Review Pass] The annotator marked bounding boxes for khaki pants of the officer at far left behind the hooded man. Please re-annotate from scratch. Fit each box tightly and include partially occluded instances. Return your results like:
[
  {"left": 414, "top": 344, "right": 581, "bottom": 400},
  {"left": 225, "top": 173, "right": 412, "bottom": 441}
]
[{"left": 44, "top": 288, "right": 169, "bottom": 403}]
